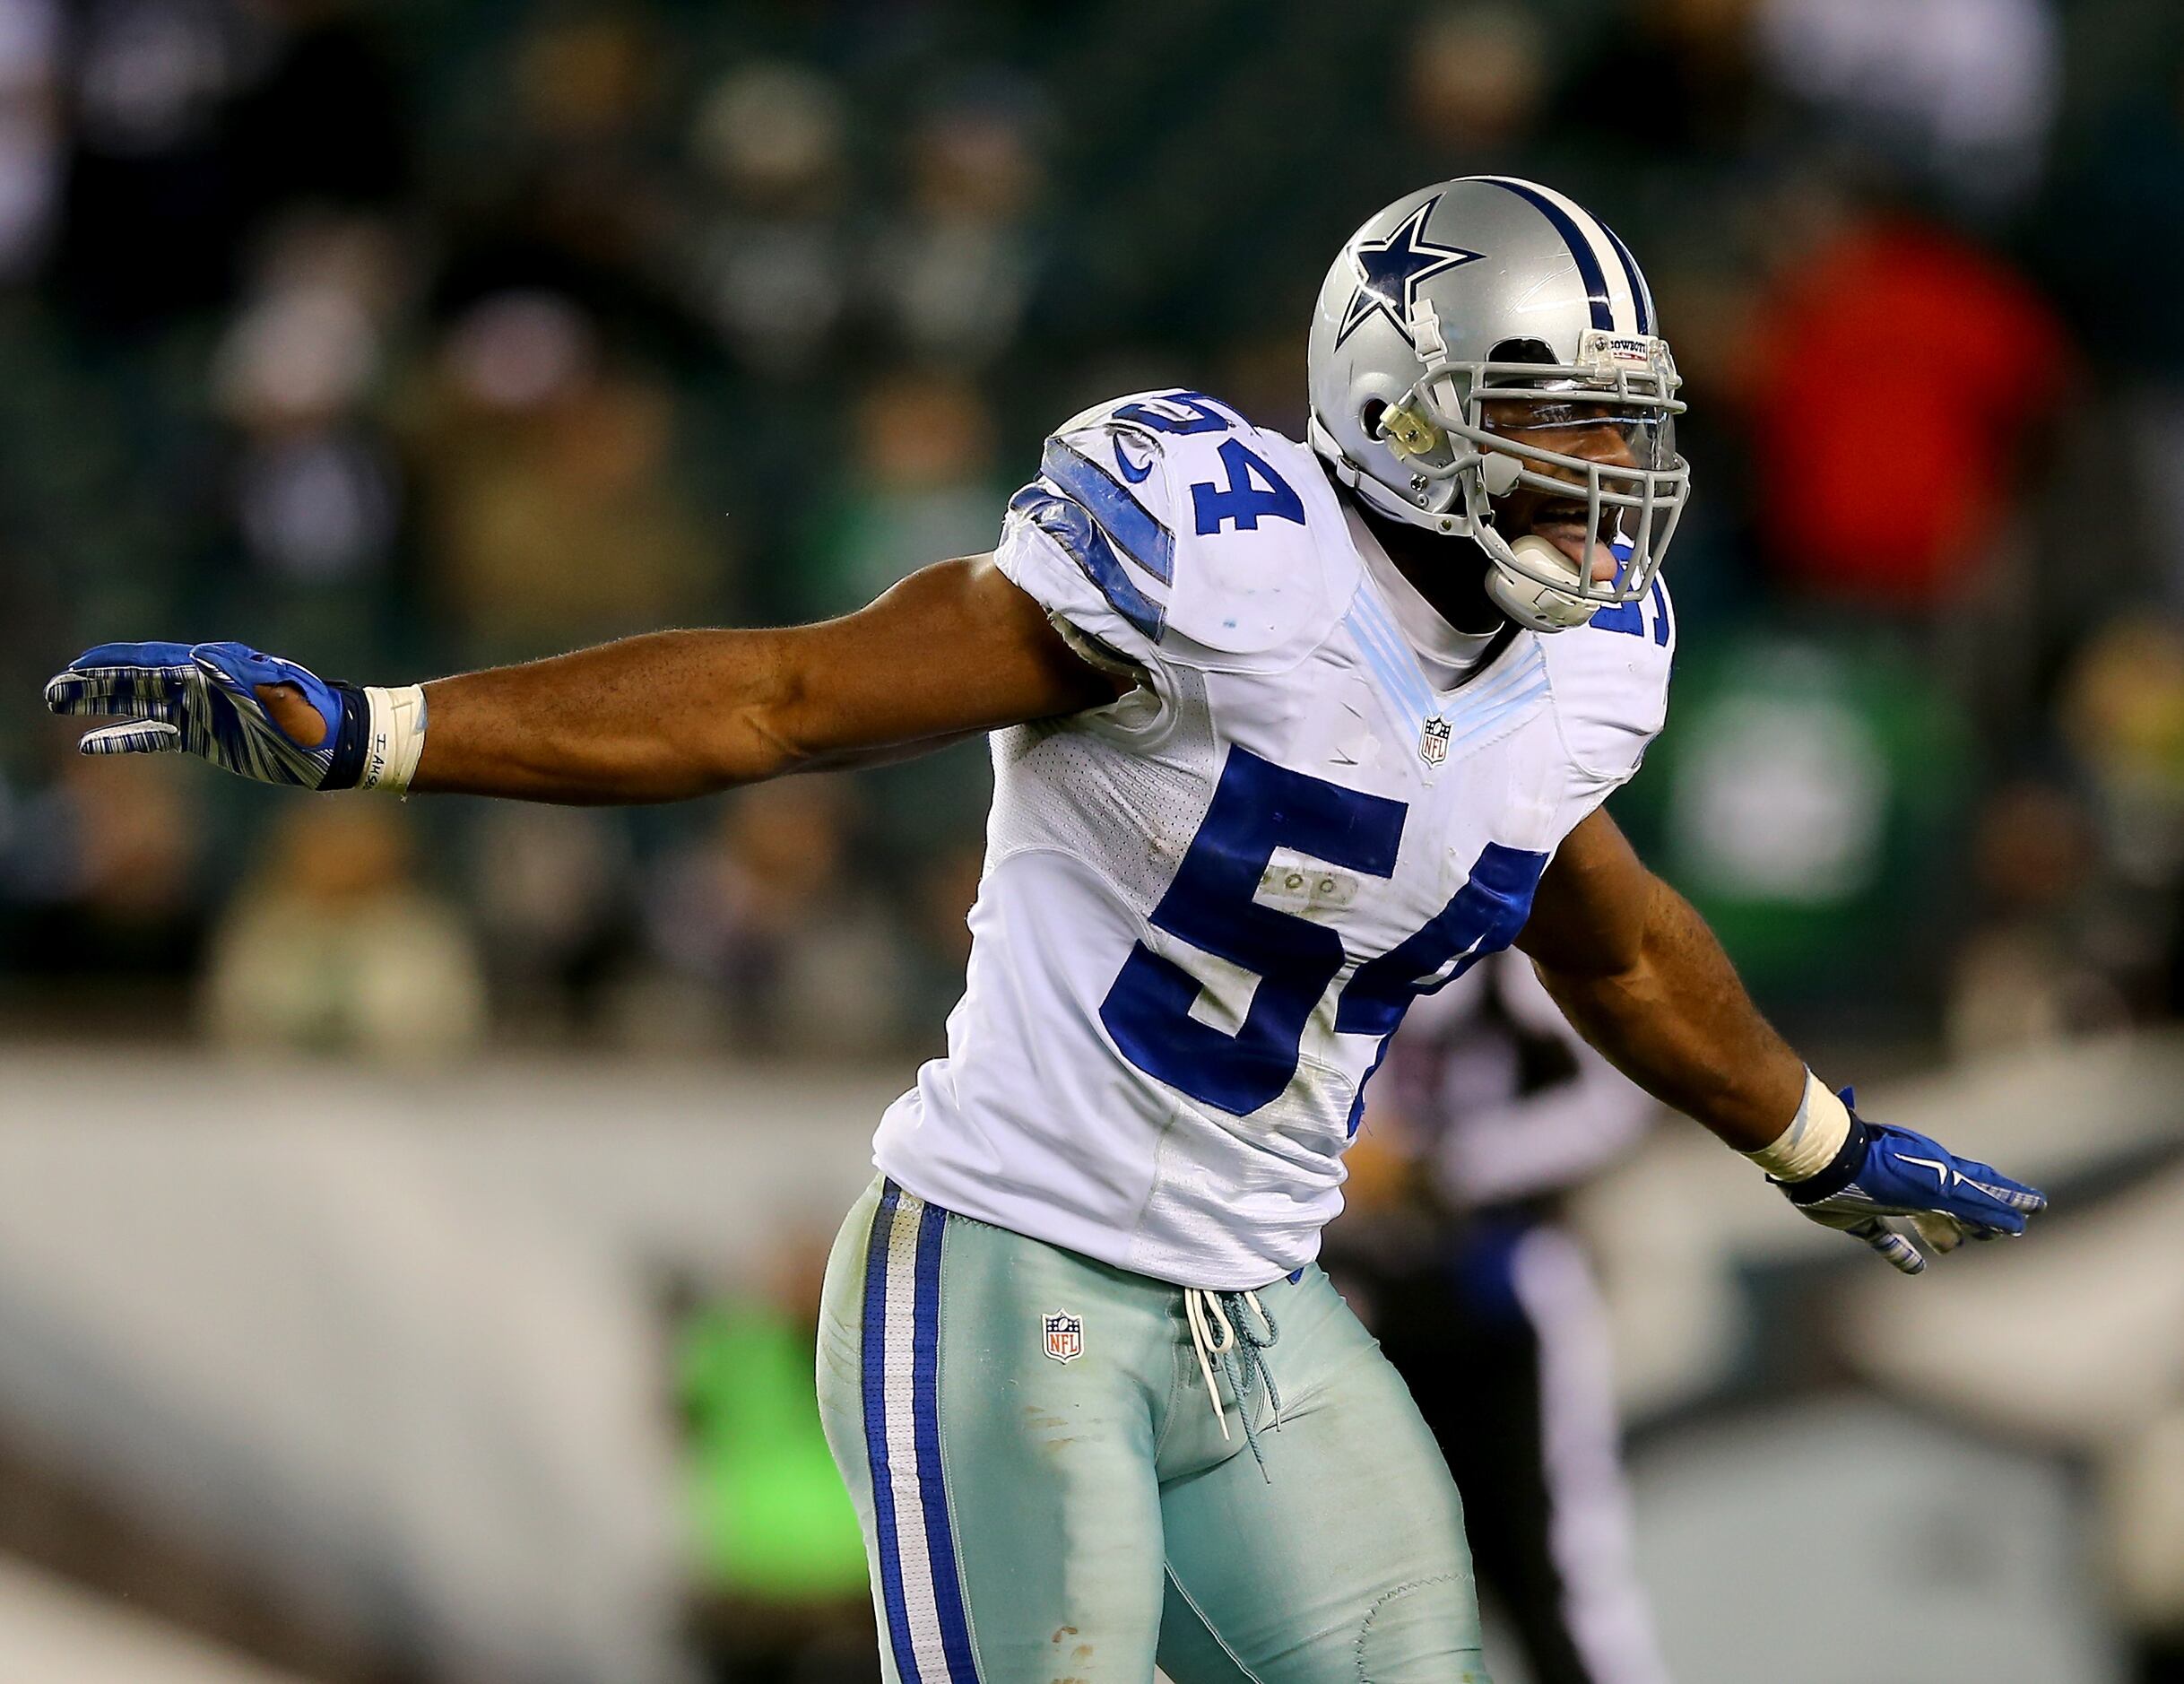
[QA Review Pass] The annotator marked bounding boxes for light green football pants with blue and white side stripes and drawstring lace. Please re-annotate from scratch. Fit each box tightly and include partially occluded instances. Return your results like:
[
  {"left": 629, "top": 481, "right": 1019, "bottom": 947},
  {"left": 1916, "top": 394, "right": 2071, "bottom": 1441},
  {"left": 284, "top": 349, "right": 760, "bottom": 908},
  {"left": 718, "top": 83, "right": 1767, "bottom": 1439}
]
[{"left": 819, "top": 1179, "right": 1487, "bottom": 1684}]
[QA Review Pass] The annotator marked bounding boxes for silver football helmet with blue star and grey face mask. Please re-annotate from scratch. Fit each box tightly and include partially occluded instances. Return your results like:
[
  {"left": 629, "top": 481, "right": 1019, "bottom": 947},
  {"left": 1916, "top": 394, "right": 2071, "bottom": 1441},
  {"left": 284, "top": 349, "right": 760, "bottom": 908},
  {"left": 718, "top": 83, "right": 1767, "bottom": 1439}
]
[{"left": 1311, "top": 175, "right": 1690, "bottom": 631}]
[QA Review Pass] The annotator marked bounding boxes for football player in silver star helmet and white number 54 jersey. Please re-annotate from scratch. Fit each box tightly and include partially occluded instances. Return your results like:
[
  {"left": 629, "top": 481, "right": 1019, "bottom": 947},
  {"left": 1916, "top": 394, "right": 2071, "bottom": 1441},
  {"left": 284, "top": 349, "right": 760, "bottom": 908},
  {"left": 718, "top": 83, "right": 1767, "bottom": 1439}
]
[{"left": 48, "top": 177, "right": 2042, "bottom": 1684}]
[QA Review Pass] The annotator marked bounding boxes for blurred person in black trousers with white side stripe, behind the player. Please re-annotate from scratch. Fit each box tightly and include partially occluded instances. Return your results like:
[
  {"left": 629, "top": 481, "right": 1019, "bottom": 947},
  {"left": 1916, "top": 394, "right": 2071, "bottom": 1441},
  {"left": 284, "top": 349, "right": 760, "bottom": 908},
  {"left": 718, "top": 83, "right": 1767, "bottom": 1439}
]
[{"left": 1328, "top": 952, "right": 1668, "bottom": 1684}]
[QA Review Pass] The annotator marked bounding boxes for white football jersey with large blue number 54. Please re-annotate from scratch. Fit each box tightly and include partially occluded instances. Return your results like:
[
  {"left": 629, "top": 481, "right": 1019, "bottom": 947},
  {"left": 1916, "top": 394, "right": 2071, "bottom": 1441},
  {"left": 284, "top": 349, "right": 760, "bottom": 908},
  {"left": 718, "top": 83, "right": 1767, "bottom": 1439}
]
[{"left": 873, "top": 391, "right": 1675, "bottom": 1289}]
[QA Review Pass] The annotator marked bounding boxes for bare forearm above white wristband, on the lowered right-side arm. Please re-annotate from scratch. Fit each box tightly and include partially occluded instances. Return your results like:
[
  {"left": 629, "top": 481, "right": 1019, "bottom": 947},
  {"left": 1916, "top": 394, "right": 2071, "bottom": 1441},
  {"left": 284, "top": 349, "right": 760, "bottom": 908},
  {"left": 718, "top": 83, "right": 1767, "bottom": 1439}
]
[{"left": 1536, "top": 873, "right": 1804, "bottom": 1151}]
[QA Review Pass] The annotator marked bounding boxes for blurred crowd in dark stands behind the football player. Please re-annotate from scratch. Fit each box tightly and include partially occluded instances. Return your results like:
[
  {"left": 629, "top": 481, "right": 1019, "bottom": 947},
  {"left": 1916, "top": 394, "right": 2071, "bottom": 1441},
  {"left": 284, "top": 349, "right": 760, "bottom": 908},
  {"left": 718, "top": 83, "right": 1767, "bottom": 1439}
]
[{"left": 0, "top": 0, "right": 2184, "bottom": 1680}]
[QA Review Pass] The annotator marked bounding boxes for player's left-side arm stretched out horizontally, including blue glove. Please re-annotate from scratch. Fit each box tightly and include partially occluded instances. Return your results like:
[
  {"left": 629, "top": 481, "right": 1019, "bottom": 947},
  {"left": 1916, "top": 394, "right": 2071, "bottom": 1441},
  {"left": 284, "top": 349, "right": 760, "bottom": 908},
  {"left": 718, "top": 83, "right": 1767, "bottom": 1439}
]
[{"left": 46, "top": 557, "right": 1122, "bottom": 803}]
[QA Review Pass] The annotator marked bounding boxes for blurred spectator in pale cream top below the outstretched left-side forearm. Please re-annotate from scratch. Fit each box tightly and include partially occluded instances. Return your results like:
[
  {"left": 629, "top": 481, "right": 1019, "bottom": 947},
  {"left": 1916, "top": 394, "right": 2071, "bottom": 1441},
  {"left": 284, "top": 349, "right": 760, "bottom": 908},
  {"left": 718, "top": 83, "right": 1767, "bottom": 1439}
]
[{"left": 204, "top": 802, "right": 485, "bottom": 1063}]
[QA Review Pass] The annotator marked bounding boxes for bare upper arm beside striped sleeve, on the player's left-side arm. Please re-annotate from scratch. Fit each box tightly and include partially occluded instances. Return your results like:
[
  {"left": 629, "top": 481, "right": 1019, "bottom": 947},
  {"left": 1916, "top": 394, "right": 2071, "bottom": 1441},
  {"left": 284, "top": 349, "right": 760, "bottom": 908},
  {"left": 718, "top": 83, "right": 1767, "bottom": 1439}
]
[{"left": 767, "top": 555, "right": 1129, "bottom": 767}]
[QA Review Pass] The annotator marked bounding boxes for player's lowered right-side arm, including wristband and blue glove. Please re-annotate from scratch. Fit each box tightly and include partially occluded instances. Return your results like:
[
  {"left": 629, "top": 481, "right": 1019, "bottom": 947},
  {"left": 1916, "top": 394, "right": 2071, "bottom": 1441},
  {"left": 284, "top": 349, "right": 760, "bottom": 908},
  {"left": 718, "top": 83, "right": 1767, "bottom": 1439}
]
[{"left": 1518, "top": 812, "right": 2047, "bottom": 1273}]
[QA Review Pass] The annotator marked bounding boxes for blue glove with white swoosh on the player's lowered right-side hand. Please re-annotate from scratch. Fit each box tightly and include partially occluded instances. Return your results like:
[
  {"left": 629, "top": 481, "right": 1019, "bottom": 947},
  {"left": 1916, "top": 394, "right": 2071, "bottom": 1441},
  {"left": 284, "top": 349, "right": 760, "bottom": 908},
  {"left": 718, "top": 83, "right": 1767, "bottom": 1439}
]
[{"left": 1775, "top": 1088, "right": 2047, "bottom": 1276}]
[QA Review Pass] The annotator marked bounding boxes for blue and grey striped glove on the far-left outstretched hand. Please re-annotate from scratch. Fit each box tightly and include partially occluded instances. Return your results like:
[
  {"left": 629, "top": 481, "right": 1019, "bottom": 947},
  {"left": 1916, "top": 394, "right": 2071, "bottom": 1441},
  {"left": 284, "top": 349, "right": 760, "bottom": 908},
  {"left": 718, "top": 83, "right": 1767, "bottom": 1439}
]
[{"left": 46, "top": 642, "right": 371, "bottom": 788}]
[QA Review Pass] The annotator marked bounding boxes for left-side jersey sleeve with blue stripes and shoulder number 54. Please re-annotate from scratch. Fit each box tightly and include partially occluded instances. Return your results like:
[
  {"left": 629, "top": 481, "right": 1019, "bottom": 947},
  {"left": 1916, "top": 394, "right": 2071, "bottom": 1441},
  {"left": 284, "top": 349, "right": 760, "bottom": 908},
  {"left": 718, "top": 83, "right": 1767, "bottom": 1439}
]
[{"left": 996, "top": 391, "right": 1354, "bottom": 673}]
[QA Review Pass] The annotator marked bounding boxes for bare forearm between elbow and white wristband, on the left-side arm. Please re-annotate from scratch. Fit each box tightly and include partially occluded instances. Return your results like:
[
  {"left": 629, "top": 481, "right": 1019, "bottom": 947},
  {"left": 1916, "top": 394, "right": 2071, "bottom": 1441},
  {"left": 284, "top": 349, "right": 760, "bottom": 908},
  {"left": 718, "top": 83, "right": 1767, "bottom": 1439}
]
[{"left": 411, "top": 631, "right": 803, "bottom": 803}]
